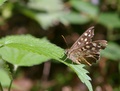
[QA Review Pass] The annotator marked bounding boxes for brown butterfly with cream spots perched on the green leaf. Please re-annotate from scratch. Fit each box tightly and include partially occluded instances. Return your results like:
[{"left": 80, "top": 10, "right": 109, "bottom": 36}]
[{"left": 66, "top": 26, "right": 107, "bottom": 66}]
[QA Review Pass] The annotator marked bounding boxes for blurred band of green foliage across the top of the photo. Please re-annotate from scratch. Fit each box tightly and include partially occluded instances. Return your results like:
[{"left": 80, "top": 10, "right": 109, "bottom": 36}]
[{"left": 1, "top": 0, "right": 120, "bottom": 29}]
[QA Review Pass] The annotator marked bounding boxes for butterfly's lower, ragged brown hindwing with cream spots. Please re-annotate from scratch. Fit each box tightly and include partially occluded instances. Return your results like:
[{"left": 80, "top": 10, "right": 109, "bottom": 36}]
[{"left": 77, "top": 40, "right": 107, "bottom": 65}]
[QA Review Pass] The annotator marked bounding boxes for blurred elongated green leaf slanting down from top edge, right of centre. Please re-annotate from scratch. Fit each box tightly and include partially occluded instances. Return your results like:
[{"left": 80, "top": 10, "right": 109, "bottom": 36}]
[{"left": 70, "top": 0, "right": 98, "bottom": 18}]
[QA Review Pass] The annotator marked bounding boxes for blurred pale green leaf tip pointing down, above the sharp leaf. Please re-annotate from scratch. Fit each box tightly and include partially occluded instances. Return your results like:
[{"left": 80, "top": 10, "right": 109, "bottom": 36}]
[{"left": 34, "top": 11, "right": 65, "bottom": 29}]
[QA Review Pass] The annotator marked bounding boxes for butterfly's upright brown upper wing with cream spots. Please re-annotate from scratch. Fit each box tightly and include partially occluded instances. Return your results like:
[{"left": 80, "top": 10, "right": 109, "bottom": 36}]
[{"left": 70, "top": 26, "right": 94, "bottom": 50}]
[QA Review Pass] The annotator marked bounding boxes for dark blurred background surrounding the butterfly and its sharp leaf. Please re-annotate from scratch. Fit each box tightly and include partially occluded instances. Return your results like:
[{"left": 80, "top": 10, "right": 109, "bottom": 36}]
[{"left": 0, "top": 0, "right": 120, "bottom": 91}]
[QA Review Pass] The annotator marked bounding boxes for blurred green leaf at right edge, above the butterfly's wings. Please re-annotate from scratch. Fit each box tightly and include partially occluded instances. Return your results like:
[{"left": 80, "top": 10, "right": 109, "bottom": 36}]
[{"left": 98, "top": 13, "right": 120, "bottom": 28}]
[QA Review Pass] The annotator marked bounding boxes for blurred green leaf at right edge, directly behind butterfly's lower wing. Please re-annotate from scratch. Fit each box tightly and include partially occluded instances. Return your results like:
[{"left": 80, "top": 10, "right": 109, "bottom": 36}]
[{"left": 101, "top": 42, "right": 120, "bottom": 61}]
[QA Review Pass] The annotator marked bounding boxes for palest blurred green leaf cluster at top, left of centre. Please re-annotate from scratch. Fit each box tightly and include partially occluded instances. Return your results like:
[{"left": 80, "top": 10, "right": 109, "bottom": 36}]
[{"left": 26, "top": 0, "right": 66, "bottom": 29}]
